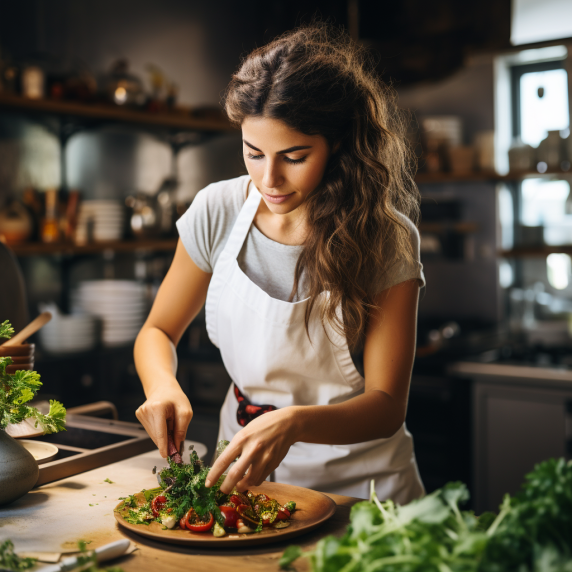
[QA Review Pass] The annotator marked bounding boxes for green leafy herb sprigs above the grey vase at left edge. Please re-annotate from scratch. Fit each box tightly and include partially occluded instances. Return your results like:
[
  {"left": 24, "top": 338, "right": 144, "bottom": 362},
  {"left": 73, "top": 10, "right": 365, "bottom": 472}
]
[{"left": 0, "top": 320, "right": 66, "bottom": 434}]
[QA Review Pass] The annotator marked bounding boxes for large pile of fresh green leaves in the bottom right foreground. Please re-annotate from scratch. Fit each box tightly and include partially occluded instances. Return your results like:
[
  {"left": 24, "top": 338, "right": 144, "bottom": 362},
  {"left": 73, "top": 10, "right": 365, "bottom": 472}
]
[{"left": 280, "top": 459, "right": 572, "bottom": 572}]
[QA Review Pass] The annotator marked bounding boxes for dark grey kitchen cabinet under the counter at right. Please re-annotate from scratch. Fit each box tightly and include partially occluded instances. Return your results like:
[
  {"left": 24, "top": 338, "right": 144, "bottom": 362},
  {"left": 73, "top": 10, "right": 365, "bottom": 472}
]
[{"left": 473, "top": 378, "right": 572, "bottom": 514}]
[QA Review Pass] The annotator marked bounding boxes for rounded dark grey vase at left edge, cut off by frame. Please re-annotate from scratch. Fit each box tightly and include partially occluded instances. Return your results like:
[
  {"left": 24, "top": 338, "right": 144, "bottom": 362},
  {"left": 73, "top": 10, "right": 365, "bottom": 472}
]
[{"left": 0, "top": 430, "right": 40, "bottom": 505}]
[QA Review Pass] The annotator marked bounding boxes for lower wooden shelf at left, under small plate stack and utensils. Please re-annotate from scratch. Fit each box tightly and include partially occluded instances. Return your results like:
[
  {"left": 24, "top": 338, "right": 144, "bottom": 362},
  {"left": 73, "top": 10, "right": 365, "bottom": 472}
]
[{"left": 10, "top": 238, "right": 177, "bottom": 256}]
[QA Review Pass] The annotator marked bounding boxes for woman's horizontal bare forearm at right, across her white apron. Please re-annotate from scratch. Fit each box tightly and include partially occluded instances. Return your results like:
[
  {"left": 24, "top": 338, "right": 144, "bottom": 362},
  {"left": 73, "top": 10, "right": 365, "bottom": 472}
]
[{"left": 289, "top": 389, "right": 406, "bottom": 445}]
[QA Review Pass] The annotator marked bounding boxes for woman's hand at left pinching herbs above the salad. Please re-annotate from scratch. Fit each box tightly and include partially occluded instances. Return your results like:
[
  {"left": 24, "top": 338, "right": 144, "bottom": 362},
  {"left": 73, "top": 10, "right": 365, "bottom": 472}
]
[{"left": 135, "top": 385, "right": 193, "bottom": 458}]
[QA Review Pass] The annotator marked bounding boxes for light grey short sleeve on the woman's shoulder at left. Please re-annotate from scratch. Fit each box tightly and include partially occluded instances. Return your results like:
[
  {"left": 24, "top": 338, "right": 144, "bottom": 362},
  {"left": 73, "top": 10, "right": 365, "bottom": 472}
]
[{"left": 177, "top": 187, "right": 213, "bottom": 273}]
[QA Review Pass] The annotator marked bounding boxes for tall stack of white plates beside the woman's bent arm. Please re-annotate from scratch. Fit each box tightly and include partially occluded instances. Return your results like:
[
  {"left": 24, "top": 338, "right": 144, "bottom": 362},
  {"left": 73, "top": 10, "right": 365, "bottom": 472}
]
[{"left": 72, "top": 280, "right": 147, "bottom": 346}]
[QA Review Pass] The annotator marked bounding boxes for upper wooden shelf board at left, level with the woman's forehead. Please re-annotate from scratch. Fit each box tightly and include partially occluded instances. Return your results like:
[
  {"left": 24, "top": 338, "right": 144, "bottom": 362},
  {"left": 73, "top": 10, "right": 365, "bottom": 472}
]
[{"left": 0, "top": 94, "right": 234, "bottom": 132}]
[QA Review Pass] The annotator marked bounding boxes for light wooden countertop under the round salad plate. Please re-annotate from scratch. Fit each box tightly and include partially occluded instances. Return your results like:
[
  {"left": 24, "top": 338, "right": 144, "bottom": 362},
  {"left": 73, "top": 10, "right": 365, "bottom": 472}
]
[{"left": 0, "top": 442, "right": 359, "bottom": 572}]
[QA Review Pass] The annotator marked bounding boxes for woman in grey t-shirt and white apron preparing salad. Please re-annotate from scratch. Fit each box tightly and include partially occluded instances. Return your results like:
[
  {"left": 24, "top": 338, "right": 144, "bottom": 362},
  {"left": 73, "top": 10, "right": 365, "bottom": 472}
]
[{"left": 135, "top": 25, "right": 424, "bottom": 504}]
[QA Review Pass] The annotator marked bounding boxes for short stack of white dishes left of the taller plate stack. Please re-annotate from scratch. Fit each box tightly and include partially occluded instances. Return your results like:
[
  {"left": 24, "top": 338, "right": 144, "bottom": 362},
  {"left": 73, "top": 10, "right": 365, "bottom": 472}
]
[{"left": 40, "top": 313, "right": 97, "bottom": 354}]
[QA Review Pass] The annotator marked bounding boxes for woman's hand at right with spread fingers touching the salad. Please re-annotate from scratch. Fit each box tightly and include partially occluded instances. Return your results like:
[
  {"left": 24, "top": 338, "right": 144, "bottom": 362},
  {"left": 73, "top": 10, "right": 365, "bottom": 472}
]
[{"left": 205, "top": 407, "right": 296, "bottom": 494}]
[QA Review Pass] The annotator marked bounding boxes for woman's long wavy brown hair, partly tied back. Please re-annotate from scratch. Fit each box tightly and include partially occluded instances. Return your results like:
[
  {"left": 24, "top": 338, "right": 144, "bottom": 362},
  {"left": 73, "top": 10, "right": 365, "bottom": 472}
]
[{"left": 224, "top": 22, "right": 419, "bottom": 349}]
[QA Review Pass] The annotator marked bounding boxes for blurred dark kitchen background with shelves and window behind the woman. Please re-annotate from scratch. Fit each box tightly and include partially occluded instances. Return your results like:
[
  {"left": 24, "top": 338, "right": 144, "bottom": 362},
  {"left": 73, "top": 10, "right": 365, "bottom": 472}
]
[{"left": 0, "top": 0, "right": 572, "bottom": 511}]
